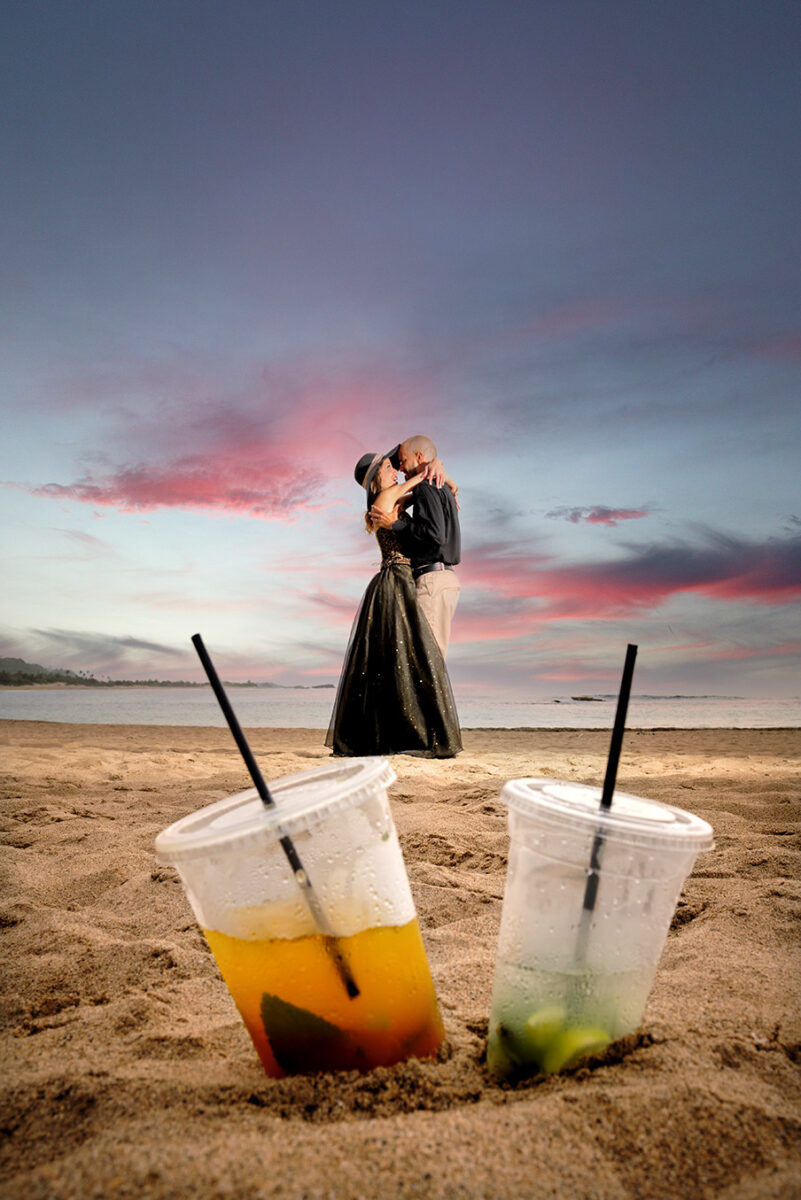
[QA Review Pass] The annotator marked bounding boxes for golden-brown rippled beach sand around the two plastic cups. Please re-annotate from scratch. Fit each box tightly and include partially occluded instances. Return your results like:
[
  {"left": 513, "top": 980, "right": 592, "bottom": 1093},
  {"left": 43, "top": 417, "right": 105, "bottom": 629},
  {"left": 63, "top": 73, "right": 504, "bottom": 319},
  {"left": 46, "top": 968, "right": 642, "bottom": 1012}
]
[{"left": 0, "top": 721, "right": 801, "bottom": 1200}]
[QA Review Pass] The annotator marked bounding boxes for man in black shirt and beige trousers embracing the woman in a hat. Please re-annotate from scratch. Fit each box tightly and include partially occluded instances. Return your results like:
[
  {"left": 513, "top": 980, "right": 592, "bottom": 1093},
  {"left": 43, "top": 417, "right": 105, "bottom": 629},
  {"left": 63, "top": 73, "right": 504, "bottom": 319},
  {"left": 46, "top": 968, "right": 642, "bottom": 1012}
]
[{"left": 371, "top": 433, "right": 462, "bottom": 658}]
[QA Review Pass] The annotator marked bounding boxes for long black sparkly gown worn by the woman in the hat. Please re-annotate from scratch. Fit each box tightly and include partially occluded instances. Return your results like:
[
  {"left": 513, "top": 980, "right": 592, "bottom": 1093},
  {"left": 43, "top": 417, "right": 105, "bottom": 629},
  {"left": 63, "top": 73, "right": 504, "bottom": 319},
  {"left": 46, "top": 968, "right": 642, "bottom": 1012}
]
[{"left": 325, "top": 529, "right": 462, "bottom": 758}]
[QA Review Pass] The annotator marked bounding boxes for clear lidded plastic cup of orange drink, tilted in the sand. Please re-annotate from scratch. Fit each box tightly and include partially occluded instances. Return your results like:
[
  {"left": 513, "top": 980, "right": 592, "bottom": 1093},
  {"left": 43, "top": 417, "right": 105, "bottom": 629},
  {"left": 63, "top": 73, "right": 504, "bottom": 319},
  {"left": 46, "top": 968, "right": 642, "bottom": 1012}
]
[{"left": 156, "top": 758, "right": 444, "bottom": 1078}]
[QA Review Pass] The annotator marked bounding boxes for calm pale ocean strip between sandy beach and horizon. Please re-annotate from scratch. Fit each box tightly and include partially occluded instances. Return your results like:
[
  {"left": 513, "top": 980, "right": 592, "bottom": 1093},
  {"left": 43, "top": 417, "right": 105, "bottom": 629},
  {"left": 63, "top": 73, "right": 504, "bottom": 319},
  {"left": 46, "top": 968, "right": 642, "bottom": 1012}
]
[{"left": 0, "top": 686, "right": 801, "bottom": 730}]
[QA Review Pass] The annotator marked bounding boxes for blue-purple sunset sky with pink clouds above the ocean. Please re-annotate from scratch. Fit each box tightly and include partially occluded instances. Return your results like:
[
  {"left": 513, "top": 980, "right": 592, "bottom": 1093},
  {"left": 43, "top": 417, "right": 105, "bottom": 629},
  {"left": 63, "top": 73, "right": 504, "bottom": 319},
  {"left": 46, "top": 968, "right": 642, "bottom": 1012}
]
[{"left": 0, "top": 0, "right": 801, "bottom": 700}]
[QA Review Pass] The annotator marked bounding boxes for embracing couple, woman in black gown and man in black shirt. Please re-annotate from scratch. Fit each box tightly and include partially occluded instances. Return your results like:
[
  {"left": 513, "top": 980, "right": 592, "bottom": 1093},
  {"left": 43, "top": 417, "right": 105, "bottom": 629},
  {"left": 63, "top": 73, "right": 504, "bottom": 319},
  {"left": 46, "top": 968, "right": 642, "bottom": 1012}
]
[{"left": 325, "top": 434, "right": 462, "bottom": 758}]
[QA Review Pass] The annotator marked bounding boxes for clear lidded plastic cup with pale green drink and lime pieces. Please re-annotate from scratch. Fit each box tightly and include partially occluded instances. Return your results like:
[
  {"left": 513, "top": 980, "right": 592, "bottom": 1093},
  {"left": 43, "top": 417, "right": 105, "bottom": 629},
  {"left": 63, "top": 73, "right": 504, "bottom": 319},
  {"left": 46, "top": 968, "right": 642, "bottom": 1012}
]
[{"left": 487, "top": 779, "right": 712, "bottom": 1076}]
